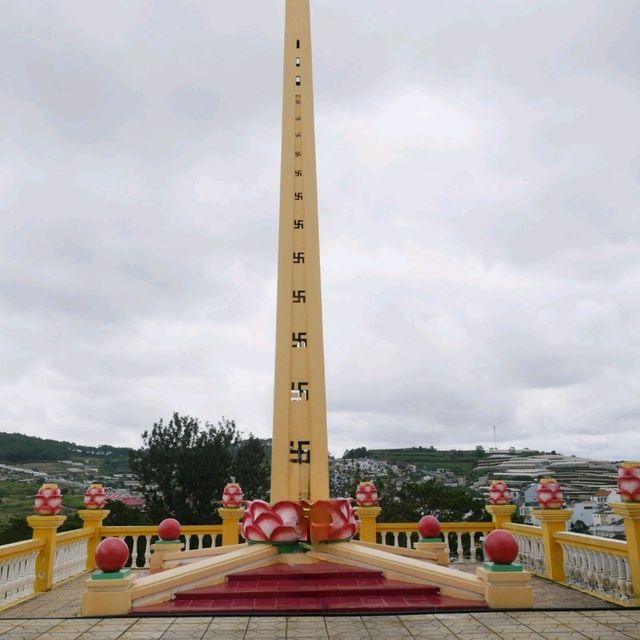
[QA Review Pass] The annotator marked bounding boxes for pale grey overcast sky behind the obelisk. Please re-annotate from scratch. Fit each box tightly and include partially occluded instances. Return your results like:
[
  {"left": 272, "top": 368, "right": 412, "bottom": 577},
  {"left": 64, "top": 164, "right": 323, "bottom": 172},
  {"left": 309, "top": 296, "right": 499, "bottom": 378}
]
[{"left": 0, "top": 0, "right": 640, "bottom": 459}]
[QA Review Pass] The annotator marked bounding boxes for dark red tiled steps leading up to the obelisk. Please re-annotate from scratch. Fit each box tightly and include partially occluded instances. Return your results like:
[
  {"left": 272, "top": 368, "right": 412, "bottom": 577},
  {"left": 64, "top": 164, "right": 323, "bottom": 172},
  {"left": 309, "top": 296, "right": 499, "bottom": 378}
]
[{"left": 131, "top": 562, "right": 487, "bottom": 615}]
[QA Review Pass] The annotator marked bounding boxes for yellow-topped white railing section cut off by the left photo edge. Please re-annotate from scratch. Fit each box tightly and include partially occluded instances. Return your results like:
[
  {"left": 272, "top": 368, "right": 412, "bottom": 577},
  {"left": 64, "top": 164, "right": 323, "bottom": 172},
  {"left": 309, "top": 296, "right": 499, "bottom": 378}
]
[{"left": 0, "top": 540, "right": 45, "bottom": 611}]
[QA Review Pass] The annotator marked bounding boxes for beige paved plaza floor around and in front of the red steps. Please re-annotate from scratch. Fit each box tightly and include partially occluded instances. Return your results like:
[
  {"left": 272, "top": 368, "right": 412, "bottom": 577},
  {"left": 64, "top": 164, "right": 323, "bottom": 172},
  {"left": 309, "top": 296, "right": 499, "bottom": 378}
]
[{"left": 0, "top": 576, "right": 640, "bottom": 640}]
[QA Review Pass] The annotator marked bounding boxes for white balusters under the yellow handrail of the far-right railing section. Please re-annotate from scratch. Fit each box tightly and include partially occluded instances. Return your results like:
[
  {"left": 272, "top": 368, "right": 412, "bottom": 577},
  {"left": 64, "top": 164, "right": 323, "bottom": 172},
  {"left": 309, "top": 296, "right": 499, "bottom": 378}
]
[{"left": 560, "top": 540, "right": 633, "bottom": 602}]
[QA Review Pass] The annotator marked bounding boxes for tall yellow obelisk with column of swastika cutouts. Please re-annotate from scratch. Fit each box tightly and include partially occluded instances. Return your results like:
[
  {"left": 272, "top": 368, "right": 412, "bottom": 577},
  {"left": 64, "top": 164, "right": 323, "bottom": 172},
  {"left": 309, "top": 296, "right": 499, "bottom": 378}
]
[{"left": 271, "top": 0, "right": 329, "bottom": 503}]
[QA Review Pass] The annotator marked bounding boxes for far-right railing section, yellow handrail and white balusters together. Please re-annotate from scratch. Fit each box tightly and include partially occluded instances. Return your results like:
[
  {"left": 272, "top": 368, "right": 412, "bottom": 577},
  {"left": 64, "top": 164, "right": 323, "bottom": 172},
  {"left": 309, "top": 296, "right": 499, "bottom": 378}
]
[{"left": 554, "top": 531, "right": 634, "bottom": 604}]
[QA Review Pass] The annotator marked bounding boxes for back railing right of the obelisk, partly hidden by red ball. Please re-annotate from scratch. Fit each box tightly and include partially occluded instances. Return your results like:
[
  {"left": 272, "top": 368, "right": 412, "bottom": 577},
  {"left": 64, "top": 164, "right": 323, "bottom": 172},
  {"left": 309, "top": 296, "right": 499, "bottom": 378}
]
[{"left": 376, "top": 522, "right": 495, "bottom": 562}]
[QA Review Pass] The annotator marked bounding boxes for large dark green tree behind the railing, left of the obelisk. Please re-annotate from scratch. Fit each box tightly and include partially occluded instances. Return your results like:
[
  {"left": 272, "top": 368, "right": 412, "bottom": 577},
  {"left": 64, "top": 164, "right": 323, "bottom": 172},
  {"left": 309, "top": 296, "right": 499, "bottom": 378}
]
[{"left": 129, "top": 413, "right": 268, "bottom": 524}]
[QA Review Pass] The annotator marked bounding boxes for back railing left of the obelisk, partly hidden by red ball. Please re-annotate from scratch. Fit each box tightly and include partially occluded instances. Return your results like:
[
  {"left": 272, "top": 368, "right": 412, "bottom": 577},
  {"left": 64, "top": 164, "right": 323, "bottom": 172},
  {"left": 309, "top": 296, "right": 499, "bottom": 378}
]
[{"left": 100, "top": 524, "right": 222, "bottom": 569}]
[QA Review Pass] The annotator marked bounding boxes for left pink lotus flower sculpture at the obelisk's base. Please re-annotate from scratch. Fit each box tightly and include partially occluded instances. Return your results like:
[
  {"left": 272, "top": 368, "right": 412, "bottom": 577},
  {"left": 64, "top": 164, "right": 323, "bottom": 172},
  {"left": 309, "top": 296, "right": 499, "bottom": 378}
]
[{"left": 242, "top": 500, "right": 306, "bottom": 542}]
